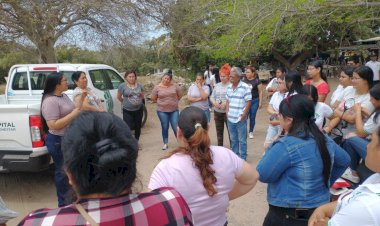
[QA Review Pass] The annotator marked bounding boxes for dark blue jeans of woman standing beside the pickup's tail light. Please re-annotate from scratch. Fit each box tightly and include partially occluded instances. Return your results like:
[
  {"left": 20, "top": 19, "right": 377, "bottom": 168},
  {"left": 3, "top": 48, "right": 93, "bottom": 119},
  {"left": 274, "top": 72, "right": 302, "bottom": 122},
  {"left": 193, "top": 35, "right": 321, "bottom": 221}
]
[{"left": 45, "top": 133, "right": 70, "bottom": 207}]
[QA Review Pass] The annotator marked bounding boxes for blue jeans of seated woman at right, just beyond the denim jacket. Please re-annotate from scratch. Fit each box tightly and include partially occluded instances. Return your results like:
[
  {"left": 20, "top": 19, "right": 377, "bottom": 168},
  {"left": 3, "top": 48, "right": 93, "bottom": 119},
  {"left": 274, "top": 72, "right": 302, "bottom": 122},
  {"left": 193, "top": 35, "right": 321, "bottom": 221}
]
[{"left": 342, "top": 137, "right": 369, "bottom": 171}]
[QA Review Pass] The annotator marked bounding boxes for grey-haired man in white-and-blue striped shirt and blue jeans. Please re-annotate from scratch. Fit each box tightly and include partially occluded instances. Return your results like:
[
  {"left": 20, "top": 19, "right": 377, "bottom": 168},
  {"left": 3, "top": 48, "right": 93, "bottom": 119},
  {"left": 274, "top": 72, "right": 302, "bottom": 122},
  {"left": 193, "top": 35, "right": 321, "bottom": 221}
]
[{"left": 226, "top": 67, "right": 252, "bottom": 160}]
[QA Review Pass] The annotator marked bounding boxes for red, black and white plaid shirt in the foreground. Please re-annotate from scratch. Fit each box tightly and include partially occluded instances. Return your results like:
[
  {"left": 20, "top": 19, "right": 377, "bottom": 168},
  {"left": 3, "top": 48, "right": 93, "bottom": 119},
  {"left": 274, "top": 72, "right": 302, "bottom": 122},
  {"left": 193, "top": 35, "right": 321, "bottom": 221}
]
[{"left": 19, "top": 188, "right": 193, "bottom": 226}]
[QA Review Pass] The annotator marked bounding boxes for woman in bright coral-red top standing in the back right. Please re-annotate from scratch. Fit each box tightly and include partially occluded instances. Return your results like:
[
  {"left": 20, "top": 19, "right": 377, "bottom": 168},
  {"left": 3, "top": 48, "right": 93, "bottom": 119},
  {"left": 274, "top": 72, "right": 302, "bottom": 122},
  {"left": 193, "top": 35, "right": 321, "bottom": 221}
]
[{"left": 305, "top": 60, "right": 330, "bottom": 102}]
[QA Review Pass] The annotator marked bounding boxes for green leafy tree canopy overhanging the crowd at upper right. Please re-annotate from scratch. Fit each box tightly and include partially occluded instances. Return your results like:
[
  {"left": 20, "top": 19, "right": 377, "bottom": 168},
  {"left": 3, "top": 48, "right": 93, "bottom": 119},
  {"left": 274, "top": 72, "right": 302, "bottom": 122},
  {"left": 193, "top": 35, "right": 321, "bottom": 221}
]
[{"left": 168, "top": 0, "right": 380, "bottom": 69}]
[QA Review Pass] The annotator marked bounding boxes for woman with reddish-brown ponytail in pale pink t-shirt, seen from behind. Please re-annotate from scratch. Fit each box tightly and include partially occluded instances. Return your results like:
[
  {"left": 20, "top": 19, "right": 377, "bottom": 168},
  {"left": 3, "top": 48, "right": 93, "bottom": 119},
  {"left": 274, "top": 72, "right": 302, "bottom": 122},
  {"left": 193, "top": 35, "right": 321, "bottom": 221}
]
[{"left": 148, "top": 107, "right": 258, "bottom": 226}]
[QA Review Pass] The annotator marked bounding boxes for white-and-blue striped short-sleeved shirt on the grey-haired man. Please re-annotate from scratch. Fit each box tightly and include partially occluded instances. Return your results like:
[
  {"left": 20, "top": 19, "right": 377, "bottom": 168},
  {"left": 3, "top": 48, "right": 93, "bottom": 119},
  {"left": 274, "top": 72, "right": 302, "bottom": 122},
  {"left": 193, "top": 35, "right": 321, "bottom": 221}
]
[{"left": 226, "top": 81, "right": 252, "bottom": 123}]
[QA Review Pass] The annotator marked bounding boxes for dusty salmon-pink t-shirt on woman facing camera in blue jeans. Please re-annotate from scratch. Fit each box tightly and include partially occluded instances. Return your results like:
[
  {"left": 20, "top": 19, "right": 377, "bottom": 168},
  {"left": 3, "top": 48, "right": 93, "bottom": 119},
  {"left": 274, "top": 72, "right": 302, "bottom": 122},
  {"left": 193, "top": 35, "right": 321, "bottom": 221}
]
[{"left": 152, "top": 84, "right": 181, "bottom": 112}]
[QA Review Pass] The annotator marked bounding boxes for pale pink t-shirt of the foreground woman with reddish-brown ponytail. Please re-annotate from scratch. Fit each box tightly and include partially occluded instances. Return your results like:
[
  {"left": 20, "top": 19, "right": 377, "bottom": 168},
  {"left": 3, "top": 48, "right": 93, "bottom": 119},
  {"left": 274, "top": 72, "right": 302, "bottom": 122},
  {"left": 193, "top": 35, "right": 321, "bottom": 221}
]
[{"left": 148, "top": 146, "right": 243, "bottom": 226}]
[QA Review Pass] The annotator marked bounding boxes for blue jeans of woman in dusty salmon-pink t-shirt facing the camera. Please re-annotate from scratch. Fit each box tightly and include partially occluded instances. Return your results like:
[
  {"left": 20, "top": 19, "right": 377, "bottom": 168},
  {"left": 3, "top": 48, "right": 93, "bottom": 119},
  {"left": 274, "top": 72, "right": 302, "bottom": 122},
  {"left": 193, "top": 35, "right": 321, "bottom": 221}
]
[{"left": 157, "top": 110, "right": 179, "bottom": 144}]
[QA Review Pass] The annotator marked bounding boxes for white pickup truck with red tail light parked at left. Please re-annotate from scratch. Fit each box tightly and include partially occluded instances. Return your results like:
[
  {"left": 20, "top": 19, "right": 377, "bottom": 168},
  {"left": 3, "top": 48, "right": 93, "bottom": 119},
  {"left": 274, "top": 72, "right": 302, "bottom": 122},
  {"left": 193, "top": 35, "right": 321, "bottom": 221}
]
[{"left": 0, "top": 64, "right": 124, "bottom": 172}]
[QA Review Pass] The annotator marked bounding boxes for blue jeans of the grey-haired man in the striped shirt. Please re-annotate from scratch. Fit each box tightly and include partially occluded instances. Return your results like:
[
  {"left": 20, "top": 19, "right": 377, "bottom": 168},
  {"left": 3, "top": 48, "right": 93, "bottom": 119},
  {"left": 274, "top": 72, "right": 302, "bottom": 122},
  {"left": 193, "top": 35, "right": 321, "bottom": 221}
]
[{"left": 227, "top": 119, "right": 247, "bottom": 160}]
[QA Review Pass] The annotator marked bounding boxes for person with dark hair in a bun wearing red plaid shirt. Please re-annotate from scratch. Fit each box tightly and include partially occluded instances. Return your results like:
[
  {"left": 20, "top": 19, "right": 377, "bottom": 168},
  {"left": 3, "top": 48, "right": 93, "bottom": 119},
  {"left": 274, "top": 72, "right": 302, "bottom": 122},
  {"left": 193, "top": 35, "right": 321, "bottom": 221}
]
[{"left": 19, "top": 111, "right": 193, "bottom": 226}]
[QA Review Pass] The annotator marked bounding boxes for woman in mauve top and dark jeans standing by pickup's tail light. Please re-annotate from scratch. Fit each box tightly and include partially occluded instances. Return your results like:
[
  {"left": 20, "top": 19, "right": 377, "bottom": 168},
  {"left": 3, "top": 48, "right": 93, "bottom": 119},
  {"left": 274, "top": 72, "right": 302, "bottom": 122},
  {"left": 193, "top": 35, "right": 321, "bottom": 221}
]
[{"left": 41, "top": 72, "right": 87, "bottom": 207}]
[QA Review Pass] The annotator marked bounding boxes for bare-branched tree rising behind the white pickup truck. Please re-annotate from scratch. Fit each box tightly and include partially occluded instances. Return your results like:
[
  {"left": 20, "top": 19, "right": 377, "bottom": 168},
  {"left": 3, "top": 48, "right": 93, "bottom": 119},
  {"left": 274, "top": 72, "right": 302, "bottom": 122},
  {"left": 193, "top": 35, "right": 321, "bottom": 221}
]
[{"left": 0, "top": 0, "right": 160, "bottom": 63}]
